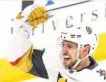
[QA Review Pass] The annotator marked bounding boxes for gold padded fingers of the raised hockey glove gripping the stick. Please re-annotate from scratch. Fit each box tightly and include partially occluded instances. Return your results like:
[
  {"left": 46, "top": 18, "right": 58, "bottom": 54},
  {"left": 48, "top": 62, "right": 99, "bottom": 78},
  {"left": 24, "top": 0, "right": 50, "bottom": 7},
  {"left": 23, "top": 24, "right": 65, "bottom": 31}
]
[{"left": 28, "top": 6, "right": 47, "bottom": 27}]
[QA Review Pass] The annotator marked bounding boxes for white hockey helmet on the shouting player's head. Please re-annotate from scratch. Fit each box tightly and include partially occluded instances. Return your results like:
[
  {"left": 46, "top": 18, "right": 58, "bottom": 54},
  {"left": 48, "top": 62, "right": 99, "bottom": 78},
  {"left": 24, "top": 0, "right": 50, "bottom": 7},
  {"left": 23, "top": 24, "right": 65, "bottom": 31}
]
[{"left": 59, "top": 26, "right": 98, "bottom": 54}]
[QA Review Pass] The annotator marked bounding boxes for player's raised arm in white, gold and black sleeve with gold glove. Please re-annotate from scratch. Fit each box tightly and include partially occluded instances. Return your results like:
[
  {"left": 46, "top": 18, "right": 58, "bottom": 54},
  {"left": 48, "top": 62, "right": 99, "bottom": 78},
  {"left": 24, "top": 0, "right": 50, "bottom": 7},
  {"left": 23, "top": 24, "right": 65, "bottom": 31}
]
[{"left": 0, "top": 5, "right": 48, "bottom": 78}]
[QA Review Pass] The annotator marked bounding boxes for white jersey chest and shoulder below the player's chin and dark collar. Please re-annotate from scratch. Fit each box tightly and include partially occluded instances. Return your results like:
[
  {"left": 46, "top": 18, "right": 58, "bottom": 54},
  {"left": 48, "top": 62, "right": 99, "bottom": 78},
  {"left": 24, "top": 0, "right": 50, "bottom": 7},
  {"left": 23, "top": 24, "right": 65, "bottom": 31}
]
[{"left": 57, "top": 58, "right": 106, "bottom": 82}]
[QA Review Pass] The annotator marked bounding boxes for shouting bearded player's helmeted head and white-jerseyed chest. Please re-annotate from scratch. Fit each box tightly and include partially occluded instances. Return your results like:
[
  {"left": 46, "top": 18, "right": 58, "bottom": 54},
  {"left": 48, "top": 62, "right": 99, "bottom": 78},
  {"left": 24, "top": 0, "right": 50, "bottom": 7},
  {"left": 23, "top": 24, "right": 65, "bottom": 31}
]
[{"left": 53, "top": 19, "right": 106, "bottom": 82}]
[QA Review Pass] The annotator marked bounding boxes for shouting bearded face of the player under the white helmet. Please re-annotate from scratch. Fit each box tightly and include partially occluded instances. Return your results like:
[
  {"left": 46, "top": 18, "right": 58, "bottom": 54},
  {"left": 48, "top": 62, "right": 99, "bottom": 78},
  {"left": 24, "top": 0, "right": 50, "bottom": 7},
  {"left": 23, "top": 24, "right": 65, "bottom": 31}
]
[{"left": 62, "top": 40, "right": 78, "bottom": 67}]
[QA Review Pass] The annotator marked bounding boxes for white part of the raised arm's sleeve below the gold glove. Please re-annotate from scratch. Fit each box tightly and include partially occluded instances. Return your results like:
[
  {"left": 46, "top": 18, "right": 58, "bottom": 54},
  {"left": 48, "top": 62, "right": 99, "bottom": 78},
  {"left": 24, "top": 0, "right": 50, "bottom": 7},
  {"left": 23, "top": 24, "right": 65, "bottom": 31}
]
[{"left": 5, "top": 6, "right": 33, "bottom": 62}]
